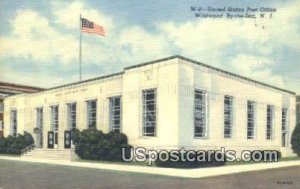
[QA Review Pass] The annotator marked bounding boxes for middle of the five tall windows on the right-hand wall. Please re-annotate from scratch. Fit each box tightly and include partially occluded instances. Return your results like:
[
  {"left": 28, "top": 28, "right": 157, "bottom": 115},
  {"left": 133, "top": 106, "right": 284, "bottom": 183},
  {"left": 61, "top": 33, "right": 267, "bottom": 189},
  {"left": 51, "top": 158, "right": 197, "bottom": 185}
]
[{"left": 247, "top": 101, "right": 255, "bottom": 139}]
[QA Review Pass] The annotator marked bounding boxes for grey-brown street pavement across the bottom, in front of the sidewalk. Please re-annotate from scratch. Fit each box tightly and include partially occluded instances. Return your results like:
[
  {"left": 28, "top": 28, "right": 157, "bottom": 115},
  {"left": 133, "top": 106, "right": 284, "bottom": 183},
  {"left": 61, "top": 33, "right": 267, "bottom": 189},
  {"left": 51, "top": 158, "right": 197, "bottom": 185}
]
[{"left": 0, "top": 160, "right": 300, "bottom": 189}]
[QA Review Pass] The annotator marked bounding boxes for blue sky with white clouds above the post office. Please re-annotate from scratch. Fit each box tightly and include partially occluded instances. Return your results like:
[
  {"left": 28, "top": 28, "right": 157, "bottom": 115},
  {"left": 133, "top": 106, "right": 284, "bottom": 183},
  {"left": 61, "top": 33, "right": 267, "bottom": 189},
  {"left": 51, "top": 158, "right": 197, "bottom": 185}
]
[{"left": 0, "top": 0, "right": 300, "bottom": 93}]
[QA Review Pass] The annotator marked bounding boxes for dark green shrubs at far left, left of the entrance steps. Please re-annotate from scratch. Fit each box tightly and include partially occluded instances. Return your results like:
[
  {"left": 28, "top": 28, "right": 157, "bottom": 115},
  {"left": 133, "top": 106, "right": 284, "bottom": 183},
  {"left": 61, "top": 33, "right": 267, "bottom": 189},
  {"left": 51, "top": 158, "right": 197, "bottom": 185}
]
[{"left": 0, "top": 132, "right": 34, "bottom": 154}]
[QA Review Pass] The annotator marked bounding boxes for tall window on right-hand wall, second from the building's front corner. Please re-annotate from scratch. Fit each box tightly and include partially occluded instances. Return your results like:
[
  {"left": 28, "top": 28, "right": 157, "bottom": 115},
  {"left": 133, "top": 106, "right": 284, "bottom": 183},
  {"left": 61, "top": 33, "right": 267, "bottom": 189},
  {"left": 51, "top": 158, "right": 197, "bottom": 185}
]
[{"left": 224, "top": 96, "right": 233, "bottom": 138}]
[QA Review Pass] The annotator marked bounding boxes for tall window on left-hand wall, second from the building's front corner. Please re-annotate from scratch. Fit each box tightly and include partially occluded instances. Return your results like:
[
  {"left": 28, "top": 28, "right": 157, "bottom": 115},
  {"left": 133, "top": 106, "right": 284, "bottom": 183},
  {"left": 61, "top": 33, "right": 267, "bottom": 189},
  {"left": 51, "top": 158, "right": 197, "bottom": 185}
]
[{"left": 109, "top": 97, "right": 121, "bottom": 133}]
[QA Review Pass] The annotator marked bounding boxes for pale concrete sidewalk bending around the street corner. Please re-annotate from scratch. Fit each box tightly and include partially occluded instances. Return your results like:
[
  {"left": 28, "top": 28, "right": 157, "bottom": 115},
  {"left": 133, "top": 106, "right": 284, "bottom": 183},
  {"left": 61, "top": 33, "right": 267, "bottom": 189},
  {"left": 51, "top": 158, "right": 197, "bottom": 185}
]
[{"left": 0, "top": 156, "right": 300, "bottom": 178}]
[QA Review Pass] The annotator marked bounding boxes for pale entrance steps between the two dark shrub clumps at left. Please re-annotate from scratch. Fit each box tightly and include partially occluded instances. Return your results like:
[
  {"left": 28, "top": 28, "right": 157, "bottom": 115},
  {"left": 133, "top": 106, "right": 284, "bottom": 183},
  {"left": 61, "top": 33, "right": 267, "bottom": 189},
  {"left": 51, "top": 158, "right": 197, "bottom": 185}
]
[{"left": 21, "top": 148, "right": 76, "bottom": 160}]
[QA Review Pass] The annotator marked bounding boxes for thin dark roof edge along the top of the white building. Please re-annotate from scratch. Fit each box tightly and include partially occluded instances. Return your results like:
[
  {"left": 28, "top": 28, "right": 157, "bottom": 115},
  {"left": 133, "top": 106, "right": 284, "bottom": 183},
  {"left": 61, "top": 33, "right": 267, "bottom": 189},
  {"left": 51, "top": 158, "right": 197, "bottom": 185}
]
[{"left": 7, "top": 55, "right": 296, "bottom": 95}]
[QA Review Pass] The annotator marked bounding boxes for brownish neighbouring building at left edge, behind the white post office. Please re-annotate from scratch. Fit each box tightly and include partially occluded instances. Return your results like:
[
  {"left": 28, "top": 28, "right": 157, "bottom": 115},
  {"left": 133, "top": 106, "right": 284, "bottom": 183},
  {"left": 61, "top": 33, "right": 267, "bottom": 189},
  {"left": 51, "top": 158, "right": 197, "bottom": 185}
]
[{"left": 0, "top": 82, "right": 44, "bottom": 137}]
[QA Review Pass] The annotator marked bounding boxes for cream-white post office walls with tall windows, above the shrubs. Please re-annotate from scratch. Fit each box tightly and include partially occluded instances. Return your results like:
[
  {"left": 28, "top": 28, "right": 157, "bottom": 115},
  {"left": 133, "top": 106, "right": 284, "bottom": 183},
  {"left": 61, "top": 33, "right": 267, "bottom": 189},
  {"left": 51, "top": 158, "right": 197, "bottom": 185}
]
[{"left": 4, "top": 56, "right": 296, "bottom": 156}]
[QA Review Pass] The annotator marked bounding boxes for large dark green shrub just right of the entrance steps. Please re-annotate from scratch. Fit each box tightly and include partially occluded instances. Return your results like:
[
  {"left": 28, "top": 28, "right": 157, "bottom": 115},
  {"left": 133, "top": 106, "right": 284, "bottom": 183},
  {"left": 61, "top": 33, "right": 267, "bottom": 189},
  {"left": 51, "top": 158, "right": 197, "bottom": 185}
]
[{"left": 73, "top": 129, "right": 131, "bottom": 161}]
